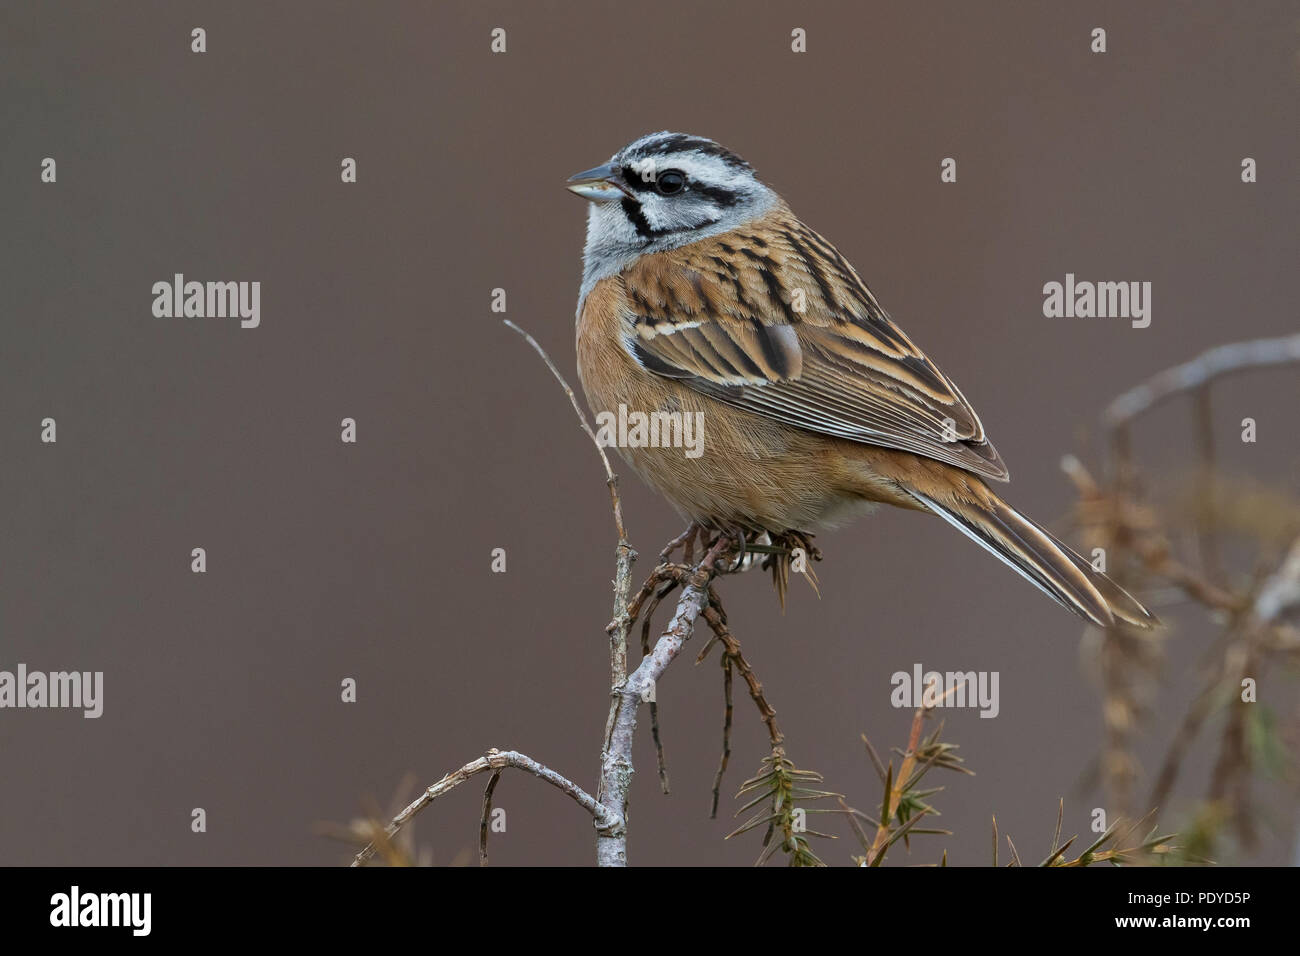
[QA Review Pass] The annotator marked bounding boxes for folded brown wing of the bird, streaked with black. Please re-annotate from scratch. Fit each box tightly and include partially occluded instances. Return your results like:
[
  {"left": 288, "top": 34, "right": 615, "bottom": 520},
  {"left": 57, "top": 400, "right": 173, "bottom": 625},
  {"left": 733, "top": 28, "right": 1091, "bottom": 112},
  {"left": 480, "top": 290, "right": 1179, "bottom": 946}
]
[{"left": 623, "top": 217, "right": 1009, "bottom": 481}]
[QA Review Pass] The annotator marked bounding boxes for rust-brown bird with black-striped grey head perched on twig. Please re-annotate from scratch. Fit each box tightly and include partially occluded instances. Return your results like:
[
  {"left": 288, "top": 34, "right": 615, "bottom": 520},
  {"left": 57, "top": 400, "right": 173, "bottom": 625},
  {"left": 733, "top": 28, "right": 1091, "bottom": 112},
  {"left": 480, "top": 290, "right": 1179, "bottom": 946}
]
[{"left": 566, "top": 131, "right": 1160, "bottom": 628}]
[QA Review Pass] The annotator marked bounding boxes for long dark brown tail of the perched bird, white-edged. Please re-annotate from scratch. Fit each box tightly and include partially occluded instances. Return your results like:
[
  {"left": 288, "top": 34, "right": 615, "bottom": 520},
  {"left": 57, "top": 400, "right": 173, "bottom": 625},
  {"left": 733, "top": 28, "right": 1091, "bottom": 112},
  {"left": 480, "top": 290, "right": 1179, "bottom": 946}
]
[{"left": 907, "top": 483, "right": 1160, "bottom": 627}]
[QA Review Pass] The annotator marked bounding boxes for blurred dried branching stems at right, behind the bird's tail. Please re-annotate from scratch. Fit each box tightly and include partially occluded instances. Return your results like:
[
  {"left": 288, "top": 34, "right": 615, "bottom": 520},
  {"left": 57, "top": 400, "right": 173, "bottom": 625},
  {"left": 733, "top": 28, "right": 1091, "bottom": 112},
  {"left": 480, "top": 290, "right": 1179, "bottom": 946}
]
[{"left": 1081, "top": 334, "right": 1300, "bottom": 844}]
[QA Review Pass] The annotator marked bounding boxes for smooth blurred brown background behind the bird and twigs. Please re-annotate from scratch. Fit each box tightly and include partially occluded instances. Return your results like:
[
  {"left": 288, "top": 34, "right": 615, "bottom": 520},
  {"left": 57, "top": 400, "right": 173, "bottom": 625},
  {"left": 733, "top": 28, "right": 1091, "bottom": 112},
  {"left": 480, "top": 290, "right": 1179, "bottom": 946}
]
[{"left": 0, "top": 0, "right": 1300, "bottom": 865}]
